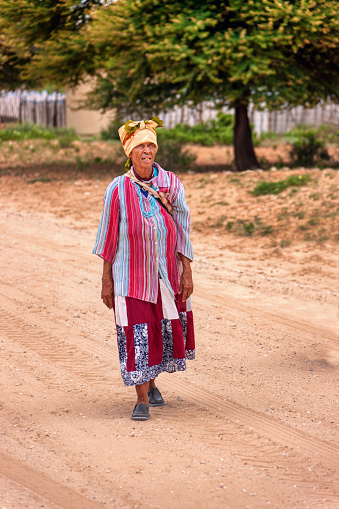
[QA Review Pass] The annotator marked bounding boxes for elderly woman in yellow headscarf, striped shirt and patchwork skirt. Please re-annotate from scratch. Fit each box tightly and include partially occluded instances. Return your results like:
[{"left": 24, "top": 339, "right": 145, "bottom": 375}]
[{"left": 93, "top": 117, "right": 195, "bottom": 420}]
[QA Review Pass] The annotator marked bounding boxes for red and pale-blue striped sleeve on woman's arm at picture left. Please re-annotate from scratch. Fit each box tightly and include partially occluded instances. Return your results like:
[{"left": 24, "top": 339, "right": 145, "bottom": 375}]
[{"left": 93, "top": 179, "right": 119, "bottom": 263}]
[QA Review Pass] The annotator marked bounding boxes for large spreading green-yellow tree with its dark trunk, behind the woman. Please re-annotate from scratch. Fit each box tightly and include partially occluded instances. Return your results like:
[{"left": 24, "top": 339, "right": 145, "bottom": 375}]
[{"left": 0, "top": 0, "right": 339, "bottom": 171}]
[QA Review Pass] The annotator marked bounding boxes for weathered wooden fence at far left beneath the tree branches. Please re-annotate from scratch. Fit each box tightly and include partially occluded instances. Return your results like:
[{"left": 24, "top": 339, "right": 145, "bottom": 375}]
[{"left": 0, "top": 92, "right": 66, "bottom": 127}]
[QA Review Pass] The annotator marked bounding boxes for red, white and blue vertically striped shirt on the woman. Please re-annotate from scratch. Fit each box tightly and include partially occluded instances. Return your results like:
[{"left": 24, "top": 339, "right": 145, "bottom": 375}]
[{"left": 93, "top": 163, "right": 193, "bottom": 303}]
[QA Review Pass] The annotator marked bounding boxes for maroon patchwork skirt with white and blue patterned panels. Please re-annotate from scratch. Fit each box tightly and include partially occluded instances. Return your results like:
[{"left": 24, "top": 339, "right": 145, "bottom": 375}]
[{"left": 114, "top": 279, "right": 195, "bottom": 385}]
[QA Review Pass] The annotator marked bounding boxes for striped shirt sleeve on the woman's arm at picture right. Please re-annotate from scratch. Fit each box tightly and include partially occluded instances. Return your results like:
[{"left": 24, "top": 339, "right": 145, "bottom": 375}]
[{"left": 172, "top": 178, "right": 193, "bottom": 261}]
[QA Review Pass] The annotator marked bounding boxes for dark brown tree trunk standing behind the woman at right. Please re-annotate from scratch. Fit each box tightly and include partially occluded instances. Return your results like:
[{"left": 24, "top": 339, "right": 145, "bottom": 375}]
[{"left": 233, "top": 103, "right": 259, "bottom": 171}]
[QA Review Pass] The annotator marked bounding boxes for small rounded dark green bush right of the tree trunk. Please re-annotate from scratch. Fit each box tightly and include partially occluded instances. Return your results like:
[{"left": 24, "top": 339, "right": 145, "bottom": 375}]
[{"left": 290, "top": 129, "right": 330, "bottom": 167}]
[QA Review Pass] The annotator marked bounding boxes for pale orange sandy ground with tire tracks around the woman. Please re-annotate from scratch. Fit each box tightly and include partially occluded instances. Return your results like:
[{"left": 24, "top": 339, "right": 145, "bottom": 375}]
[{"left": 0, "top": 144, "right": 339, "bottom": 509}]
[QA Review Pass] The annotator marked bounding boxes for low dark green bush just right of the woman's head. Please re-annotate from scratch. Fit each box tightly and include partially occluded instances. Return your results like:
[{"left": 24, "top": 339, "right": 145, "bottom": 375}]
[{"left": 156, "top": 140, "right": 196, "bottom": 173}]
